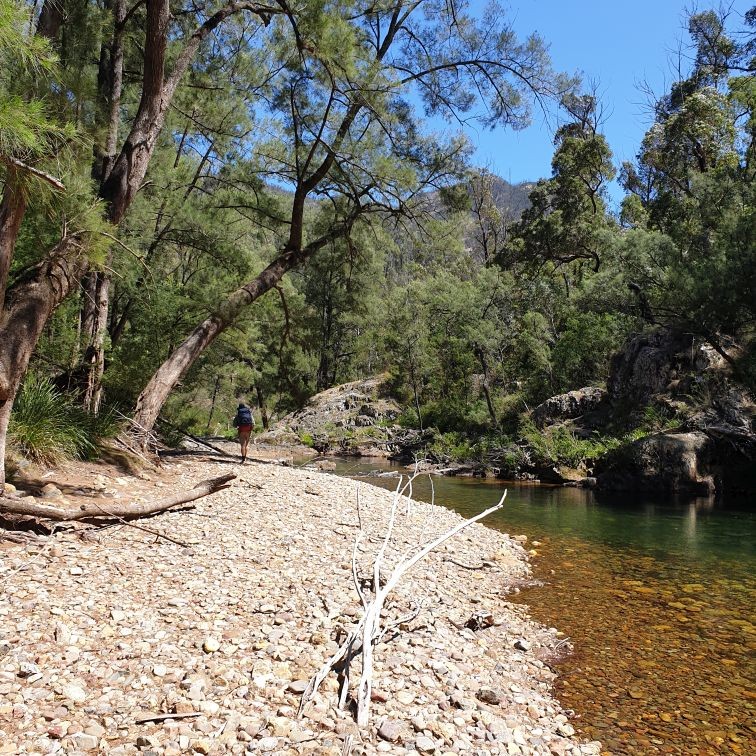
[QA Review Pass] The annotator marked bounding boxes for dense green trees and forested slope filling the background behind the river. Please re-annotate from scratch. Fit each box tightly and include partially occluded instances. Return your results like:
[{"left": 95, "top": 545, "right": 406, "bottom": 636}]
[{"left": 0, "top": 0, "right": 756, "bottom": 494}]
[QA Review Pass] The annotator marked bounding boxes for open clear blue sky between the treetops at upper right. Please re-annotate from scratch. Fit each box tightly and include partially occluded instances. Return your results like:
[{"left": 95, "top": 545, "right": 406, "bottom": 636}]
[{"left": 446, "top": 0, "right": 756, "bottom": 205}]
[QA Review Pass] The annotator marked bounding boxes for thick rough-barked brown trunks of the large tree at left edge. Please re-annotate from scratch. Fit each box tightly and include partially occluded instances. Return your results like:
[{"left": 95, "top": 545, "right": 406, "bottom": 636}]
[{"left": 0, "top": 0, "right": 282, "bottom": 482}]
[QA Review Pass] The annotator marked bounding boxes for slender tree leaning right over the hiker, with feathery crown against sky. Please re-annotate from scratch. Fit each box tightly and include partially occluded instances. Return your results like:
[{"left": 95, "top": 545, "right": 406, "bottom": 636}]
[{"left": 134, "top": 0, "right": 572, "bottom": 431}]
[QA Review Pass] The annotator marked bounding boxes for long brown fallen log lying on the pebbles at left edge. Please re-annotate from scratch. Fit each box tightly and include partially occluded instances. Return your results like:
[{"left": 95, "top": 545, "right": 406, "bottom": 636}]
[{"left": 0, "top": 474, "right": 236, "bottom": 522}]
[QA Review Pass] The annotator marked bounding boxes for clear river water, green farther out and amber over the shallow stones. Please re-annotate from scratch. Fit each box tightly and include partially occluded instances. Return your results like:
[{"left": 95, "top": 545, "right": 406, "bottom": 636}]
[{"left": 318, "top": 460, "right": 756, "bottom": 756}]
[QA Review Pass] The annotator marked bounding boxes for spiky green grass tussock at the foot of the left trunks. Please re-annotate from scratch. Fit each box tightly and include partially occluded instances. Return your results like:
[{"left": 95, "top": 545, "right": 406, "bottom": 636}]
[{"left": 8, "top": 374, "right": 118, "bottom": 464}]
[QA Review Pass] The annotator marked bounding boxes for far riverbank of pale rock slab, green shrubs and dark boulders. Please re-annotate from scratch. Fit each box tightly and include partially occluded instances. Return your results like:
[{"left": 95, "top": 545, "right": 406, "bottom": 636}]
[{"left": 258, "top": 328, "right": 756, "bottom": 495}]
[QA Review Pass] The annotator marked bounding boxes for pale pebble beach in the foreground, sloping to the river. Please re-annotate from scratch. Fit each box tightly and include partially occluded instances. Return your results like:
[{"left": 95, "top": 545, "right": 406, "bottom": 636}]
[{"left": 0, "top": 455, "right": 599, "bottom": 756}]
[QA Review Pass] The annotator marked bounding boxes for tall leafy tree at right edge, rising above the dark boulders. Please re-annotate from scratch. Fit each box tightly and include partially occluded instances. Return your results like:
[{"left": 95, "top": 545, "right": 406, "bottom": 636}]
[{"left": 622, "top": 9, "right": 756, "bottom": 360}]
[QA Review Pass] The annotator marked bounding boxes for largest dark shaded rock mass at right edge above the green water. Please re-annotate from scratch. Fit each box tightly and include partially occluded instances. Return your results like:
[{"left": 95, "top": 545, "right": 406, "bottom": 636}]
[{"left": 596, "top": 330, "right": 756, "bottom": 494}]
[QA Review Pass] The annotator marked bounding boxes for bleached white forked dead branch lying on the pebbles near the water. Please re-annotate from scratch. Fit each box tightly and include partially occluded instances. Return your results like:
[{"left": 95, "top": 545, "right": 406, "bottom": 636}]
[{"left": 299, "top": 473, "right": 507, "bottom": 727}]
